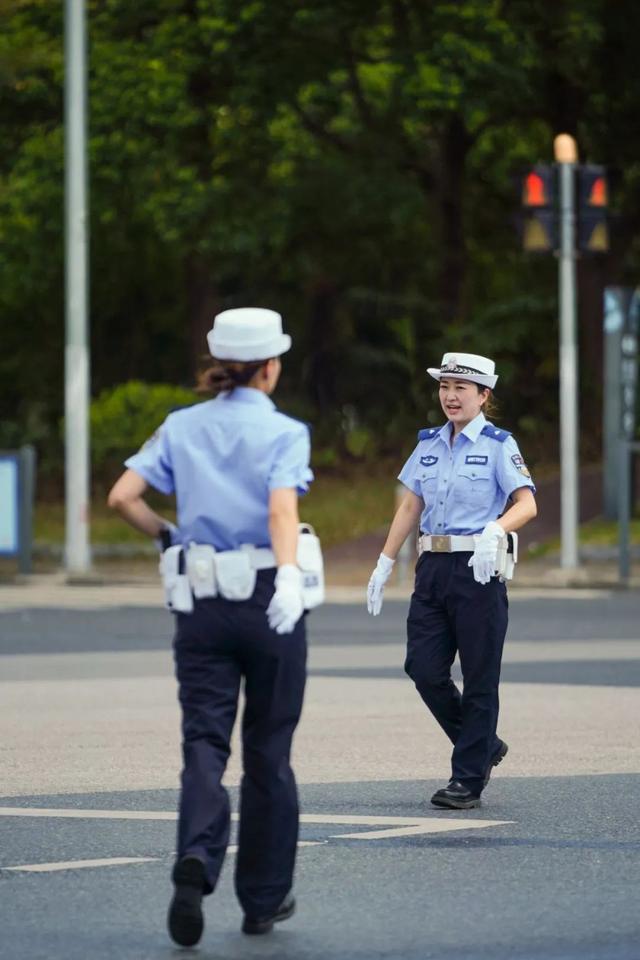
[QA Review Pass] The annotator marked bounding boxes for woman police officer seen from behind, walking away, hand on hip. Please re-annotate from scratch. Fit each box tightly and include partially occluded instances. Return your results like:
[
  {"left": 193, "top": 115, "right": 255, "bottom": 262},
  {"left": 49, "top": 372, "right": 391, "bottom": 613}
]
[{"left": 109, "top": 308, "right": 313, "bottom": 946}]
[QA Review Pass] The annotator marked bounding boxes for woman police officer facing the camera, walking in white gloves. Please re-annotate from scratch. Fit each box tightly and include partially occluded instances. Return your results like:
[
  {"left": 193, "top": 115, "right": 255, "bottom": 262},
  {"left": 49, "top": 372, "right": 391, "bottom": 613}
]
[{"left": 367, "top": 353, "right": 536, "bottom": 809}]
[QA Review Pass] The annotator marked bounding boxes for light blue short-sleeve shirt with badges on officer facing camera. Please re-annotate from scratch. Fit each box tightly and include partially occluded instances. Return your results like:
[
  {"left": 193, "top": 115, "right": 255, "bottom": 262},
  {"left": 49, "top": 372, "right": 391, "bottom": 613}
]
[{"left": 398, "top": 413, "right": 536, "bottom": 536}]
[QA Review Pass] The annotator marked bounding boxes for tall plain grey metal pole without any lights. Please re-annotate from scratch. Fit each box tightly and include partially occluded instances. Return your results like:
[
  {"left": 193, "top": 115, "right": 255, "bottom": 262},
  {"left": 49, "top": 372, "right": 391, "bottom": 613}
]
[{"left": 65, "top": 0, "right": 91, "bottom": 577}]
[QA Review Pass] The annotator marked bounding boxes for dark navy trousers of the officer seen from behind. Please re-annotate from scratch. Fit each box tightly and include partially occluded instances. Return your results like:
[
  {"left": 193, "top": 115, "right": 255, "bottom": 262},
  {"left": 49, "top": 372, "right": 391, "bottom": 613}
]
[{"left": 174, "top": 570, "right": 307, "bottom": 918}]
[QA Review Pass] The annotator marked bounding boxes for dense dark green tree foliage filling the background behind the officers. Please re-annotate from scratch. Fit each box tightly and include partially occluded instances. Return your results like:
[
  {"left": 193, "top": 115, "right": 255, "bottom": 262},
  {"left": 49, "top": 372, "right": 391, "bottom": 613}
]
[{"left": 0, "top": 0, "right": 640, "bottom": 480}]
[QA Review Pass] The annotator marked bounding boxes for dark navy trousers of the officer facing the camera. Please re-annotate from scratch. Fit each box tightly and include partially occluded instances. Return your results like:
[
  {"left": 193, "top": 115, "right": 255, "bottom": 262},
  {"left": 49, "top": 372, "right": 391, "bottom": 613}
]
[{"left": 405, "top": 553, "right": 508, "bottom": 796}]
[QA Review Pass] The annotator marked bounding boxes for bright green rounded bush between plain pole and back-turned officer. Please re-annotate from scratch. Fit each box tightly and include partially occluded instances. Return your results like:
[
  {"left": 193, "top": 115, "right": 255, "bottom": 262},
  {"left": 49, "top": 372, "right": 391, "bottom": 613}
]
[{"left": 90, "top": 380, "right": 200, "bottom": 479}]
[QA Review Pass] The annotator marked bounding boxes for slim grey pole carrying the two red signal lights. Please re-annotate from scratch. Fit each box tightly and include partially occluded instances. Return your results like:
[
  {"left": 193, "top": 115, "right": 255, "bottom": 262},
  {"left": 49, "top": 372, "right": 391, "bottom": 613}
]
[{"left": 558, "top": 158, "right": 579, "bottom": 568}]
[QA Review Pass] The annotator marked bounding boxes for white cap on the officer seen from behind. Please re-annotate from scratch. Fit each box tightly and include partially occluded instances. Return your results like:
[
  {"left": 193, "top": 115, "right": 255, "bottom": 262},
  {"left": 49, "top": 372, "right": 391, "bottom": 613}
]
[{"left": 207, "top": 307, "right": 291, "bottom": 362}]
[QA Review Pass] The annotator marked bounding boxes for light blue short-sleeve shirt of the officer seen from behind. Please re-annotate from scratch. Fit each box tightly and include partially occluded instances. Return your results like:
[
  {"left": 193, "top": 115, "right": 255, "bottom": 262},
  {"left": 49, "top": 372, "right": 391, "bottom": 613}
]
[{"left": 125, "top": 387, "right": 313, "bottom": 550}]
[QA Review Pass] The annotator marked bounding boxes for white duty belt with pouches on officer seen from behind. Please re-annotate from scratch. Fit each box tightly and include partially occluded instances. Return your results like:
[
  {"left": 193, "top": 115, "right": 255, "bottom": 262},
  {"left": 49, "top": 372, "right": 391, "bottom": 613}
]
[{"left": 160, "top": 523, "right": 324, "bottom": 613}]
